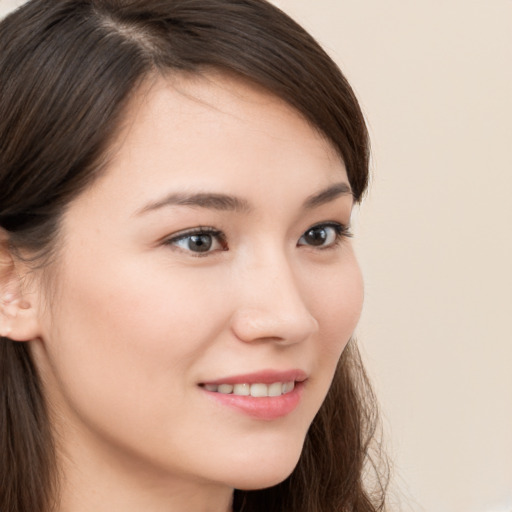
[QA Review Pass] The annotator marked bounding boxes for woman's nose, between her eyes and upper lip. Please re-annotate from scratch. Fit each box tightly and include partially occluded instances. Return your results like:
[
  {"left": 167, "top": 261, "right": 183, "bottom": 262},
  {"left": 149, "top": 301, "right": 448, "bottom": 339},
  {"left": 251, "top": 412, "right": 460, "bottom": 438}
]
[{"left": 232, "top": 251, "right": 318, "bottom": 345}]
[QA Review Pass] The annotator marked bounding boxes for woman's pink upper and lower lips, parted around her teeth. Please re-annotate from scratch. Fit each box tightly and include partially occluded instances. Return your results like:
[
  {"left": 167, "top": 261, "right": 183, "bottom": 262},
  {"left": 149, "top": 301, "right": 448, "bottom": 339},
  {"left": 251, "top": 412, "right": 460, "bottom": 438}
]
[{"left": 200, "top": 370, "right": 307, "bottom": 421}]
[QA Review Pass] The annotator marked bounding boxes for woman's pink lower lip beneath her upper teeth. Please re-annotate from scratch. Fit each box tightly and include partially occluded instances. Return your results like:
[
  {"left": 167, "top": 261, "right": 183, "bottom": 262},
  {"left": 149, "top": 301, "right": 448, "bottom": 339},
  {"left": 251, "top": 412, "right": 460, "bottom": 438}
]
[{"left": 203, "top": 382, "right": 304, "bottom": 421}]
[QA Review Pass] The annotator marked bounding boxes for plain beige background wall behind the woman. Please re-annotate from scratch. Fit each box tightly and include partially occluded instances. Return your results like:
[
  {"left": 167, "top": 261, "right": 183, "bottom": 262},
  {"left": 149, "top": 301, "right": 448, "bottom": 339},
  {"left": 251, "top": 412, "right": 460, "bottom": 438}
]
[{"left": 0, "top": 0, "right": 512, "bottom": 512}]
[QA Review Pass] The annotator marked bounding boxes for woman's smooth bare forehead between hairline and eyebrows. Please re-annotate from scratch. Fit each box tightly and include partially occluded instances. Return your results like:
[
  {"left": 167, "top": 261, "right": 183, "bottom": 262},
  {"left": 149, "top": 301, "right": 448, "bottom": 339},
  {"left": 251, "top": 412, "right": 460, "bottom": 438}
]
[{"left": 73, "top": 73, "right": 348, "bottom": 214}]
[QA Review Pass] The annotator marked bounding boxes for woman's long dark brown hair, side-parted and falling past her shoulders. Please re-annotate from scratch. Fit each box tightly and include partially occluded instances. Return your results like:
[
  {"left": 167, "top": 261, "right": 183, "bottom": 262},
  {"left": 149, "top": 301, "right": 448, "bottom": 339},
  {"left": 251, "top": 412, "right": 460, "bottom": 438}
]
[{"left": 0, "top": 0, "right": 385, "bottom": 512}]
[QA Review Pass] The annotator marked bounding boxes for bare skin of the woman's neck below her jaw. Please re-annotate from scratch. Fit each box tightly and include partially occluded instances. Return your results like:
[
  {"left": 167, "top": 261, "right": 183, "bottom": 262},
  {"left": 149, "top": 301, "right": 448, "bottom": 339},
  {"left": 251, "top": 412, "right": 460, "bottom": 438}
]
[{"left": 57, "top": 424, "right": 233, "bottom": 512}]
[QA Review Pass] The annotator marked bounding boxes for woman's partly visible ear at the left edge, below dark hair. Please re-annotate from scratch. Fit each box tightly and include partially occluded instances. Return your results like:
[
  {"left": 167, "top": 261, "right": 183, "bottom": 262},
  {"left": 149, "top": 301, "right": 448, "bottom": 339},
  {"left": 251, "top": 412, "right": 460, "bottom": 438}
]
[{"left": 0, "top": 228, "right": 39, "bottom": 341}]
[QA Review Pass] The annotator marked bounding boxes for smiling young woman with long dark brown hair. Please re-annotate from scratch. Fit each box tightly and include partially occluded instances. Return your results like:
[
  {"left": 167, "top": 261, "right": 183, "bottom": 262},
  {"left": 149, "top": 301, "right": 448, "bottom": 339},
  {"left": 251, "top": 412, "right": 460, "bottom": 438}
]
[{"left": 0, "top": 0, "right": 384, "bottom": 512}]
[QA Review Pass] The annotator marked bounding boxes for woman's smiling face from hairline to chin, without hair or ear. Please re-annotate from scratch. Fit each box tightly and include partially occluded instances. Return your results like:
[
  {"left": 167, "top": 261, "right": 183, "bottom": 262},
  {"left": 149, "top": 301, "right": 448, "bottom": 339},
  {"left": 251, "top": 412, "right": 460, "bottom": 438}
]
[{"left": 31, "top": 74, "right": 362, "bottom": 489}]
